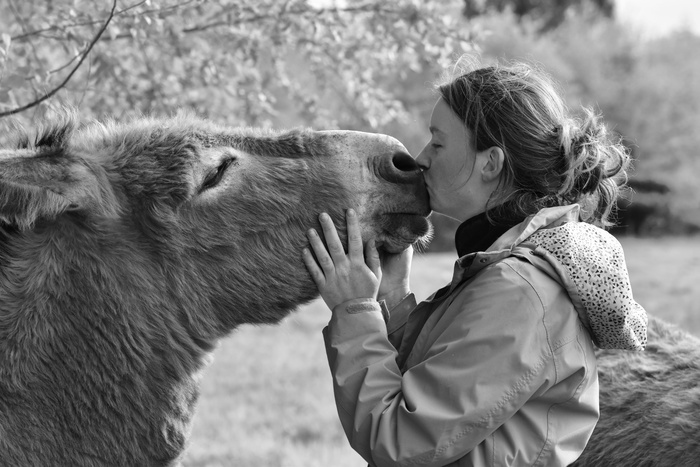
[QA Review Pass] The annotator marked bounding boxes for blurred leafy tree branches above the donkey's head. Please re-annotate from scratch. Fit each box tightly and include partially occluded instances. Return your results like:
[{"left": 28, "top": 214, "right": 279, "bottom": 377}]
[{"left": 0, "top": 0, "right": 473, "bottom": 135}]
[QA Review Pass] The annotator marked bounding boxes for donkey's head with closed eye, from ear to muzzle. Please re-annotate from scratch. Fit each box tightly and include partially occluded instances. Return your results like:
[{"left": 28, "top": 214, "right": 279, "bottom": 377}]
[{"left": 0, "top": 110, "right": 429, "bottom": 333}]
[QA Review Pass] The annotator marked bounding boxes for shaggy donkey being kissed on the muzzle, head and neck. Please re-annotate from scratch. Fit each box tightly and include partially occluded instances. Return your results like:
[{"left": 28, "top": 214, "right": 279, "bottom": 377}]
[{"left": 0, "top": 113, "right": 430, "bottom": 466}]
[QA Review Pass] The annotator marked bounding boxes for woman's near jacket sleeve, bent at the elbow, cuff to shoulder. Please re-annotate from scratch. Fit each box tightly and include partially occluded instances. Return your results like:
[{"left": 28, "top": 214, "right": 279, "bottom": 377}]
[{"left": 324, "top": 265, "right": 553, "bottom": 467}]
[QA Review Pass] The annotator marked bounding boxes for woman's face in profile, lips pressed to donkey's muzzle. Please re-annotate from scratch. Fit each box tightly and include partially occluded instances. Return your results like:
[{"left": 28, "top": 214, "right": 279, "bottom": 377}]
[{"left": 416, "top": 98, "right": 491, "bottom": 222}]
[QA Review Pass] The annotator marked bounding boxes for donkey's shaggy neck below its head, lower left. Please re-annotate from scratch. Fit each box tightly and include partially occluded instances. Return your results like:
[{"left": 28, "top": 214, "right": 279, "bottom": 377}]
[{"left": 0, "top": 226, "right": 214, "bottom": 465}]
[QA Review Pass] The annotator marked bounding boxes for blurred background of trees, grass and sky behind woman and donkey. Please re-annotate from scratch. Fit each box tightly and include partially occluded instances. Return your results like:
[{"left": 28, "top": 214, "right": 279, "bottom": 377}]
[{"left": 0, "top": 0, "right": 700, "bottom": 467}]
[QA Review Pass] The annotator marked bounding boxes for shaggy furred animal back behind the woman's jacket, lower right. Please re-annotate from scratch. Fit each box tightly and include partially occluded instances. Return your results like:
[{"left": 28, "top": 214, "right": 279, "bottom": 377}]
[{"left": 573, "top": 318, "right": 700, "bottom": 467}]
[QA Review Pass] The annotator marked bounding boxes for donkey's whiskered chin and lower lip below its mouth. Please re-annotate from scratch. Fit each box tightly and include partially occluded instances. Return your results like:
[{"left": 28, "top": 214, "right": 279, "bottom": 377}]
[{"left": 377, "top": 213, "right": 433, "bottom": 254}]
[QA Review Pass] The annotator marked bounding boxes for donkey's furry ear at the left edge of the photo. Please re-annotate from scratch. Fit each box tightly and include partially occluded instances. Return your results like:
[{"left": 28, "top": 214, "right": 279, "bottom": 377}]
[{"left": 0, "top": 147, "right": 110, "bottom": 229}]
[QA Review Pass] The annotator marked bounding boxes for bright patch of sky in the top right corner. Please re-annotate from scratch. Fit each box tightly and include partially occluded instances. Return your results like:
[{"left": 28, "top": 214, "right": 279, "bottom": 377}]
[{"left": 615, "top": 0, "right": 700, "bottom": 37}]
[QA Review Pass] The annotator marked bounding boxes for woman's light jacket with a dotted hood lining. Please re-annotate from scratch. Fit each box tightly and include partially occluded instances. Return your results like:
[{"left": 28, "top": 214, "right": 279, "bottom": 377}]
[{"left": 324, "top": 205, "right": 646, "bottom": 467}]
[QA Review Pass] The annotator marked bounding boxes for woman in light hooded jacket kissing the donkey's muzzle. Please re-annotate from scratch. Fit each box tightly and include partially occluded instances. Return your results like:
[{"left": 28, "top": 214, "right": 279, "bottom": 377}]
[{"left": 303, "top": 64, "right": 646, "bottom": 466}]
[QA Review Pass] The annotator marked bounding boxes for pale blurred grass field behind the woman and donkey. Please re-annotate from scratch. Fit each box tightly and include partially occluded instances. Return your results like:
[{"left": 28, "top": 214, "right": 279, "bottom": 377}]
[{"left": 184, "top": 237, "right": 700, "bottom": 467}]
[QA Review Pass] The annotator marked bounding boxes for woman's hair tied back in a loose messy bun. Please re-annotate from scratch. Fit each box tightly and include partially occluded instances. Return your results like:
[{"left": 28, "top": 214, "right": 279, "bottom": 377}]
[{"left": 438, "top": 59, "right": 629, "bottom": 227}]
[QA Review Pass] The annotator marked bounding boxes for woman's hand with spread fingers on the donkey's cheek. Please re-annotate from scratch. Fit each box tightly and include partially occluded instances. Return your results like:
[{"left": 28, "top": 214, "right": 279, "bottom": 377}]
[{"left": 303, "top": 209, "right": 382, "bottom": 310}]
